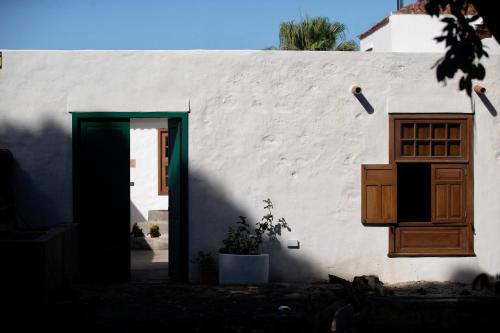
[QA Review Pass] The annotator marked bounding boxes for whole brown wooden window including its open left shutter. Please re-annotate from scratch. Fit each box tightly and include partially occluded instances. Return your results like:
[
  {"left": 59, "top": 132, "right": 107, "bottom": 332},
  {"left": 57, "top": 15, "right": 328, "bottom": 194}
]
[{"left": 361, "top": 114, "right": 474, "bottom": 256}]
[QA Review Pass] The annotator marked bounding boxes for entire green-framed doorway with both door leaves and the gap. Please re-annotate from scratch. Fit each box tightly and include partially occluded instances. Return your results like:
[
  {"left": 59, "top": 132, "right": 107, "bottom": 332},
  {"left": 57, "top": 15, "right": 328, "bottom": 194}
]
[{"left": 73, "top": 112, "right": 188, "bottom": 283}]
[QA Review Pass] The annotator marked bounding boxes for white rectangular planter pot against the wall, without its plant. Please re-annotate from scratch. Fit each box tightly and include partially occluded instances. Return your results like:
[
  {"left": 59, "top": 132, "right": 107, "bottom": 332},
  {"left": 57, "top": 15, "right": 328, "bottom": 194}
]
[{"left": 219, "top": 253, "right": 269, "bottom": 284}]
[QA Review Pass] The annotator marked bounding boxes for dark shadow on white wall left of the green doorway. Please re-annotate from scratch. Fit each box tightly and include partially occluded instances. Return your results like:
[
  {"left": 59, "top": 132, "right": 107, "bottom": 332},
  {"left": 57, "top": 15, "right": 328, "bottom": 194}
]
[{"left": 0, "top": 121, "right": 72, "bottom": 229}]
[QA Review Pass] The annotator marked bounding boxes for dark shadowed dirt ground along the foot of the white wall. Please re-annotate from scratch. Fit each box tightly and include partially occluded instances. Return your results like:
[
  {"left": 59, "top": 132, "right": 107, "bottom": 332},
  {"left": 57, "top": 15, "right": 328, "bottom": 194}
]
[{"left": 9, "top": 281, "right": 500, "bottom": 333}]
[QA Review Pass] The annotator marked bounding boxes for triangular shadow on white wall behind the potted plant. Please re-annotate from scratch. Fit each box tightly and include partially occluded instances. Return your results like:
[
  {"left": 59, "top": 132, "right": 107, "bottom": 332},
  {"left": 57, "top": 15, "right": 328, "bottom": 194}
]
[{"left": 189, "top": 167, "right": 328, "bottom": 282}]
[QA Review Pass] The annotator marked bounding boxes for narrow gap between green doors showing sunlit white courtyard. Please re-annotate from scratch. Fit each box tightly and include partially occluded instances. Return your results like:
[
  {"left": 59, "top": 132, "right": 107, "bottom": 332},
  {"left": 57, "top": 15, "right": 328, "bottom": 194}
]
[{"left": 130, "top": 118, "right": 169, "bottom": 281}]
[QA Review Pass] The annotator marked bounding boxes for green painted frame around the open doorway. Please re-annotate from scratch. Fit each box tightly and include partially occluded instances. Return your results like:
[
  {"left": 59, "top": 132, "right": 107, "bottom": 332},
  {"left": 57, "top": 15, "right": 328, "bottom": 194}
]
[{"left": 70, "top": 112, "right": 189, "bottom": 281}]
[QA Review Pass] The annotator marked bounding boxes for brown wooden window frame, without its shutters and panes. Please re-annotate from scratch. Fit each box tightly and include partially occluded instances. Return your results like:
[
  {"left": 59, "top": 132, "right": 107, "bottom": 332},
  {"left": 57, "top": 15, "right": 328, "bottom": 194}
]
[{"left": 388, "top": 113, "right": 475, "bottom": 257}]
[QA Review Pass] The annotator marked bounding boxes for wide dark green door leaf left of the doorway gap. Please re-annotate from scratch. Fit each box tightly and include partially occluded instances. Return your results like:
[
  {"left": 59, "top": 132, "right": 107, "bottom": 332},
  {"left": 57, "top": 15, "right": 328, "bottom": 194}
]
[{"left": 74, "top": 118, "right": 130, "bottom": 282}]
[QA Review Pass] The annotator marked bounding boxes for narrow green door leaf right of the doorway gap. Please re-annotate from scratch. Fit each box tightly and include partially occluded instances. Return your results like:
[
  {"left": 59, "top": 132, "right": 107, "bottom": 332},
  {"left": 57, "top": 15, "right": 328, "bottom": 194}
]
[{"left": 168, "top": 118, "right": 183, "bottom": 280}]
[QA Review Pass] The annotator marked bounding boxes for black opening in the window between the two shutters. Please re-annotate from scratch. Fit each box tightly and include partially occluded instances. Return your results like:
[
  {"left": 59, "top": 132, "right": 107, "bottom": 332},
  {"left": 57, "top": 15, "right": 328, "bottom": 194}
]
[{"left": 398, "top": 163, "right": 431, "bottom": 222}]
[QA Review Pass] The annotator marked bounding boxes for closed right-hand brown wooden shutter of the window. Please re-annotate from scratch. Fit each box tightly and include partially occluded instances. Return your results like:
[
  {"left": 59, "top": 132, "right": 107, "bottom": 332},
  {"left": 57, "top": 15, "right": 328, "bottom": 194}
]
[{"left": 431, "top": 164, "right": 467, "bottom": 223}]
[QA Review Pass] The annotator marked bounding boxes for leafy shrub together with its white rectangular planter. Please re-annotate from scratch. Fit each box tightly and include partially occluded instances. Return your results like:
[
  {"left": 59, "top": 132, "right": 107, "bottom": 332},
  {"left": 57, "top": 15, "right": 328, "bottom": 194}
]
[{"left": 219, "top": 199, "right": 291, "bottom": 284}]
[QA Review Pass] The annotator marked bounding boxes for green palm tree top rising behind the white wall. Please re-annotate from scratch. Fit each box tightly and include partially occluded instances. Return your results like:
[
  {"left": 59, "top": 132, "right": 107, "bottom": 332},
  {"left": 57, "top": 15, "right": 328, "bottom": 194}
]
[{"left": 280, "top": 16, "right": 358, "bottom": 51}]
